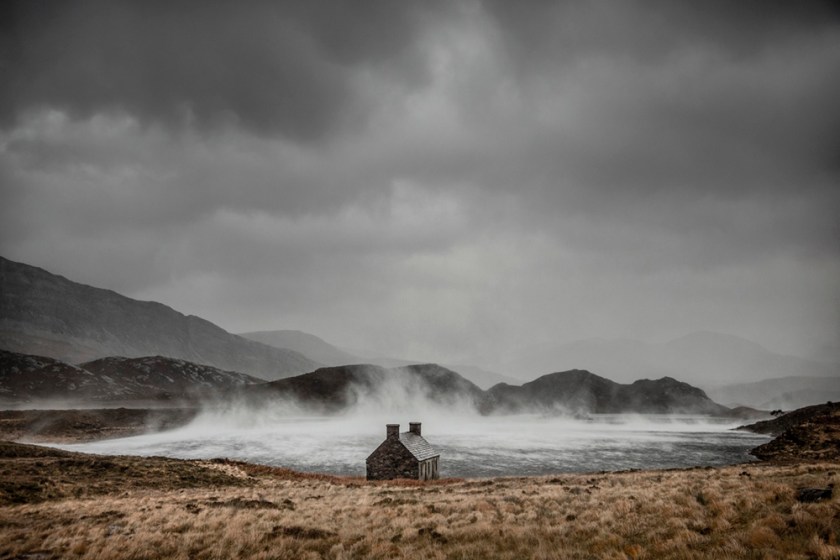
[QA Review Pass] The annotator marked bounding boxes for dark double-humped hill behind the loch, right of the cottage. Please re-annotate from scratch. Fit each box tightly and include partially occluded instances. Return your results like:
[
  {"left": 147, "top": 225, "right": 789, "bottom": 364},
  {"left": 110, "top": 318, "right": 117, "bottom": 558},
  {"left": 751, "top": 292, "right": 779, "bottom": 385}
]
[{"left": 483, "top": 369, "right": 728, "bottom": 415}]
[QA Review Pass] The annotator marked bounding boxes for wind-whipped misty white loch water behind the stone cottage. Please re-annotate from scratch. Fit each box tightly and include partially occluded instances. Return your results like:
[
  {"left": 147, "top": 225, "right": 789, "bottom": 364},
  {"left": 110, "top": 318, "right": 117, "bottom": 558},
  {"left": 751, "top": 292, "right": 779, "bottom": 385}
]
[{"left": 62, "top": 402, "right": 769, "bottom": 477}]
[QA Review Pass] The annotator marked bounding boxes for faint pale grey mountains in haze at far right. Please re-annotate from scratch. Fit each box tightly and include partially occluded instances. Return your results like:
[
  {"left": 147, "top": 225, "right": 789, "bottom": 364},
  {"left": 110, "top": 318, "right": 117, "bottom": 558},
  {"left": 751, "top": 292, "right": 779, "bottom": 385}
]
[{"left": 501, "top": 331, "right": 840, "bottom": 388}]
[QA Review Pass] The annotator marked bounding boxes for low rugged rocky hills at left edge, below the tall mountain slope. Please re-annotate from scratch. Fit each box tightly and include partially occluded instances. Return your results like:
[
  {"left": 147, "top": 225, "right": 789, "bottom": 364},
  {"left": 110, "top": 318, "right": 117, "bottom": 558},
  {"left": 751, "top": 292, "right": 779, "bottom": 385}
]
[{"left": 0, "top": 350, "right": 264, "bottom": 405}]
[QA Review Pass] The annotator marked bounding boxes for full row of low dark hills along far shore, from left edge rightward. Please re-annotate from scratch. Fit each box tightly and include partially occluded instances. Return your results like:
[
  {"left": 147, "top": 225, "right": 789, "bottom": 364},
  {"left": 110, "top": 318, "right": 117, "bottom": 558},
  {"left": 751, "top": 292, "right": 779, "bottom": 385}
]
[{"left": 0, "top": 351, "right": 729, "bottom": 416}]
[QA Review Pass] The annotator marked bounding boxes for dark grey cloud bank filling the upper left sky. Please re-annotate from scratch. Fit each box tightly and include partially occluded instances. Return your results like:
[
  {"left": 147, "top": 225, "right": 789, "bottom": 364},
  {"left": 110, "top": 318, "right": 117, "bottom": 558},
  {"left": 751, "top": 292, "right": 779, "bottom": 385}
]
[{"left": 0, "top": 0, "right": 442, "bottom": 141}]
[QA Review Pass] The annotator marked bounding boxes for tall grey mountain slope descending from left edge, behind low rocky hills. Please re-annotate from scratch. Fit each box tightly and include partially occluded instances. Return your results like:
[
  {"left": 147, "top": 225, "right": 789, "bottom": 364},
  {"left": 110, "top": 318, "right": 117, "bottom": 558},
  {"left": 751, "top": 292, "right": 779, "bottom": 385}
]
[{"left": 0, "top": 257, "right": 321, "bottom": 379}]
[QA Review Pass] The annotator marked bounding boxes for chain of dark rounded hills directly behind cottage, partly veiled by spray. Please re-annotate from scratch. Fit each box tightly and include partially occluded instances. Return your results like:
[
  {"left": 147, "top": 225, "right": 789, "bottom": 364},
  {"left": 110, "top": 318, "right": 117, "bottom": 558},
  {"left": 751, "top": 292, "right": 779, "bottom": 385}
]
[{"left": 243, "top": 364, "right": 729, "bottom": 416}]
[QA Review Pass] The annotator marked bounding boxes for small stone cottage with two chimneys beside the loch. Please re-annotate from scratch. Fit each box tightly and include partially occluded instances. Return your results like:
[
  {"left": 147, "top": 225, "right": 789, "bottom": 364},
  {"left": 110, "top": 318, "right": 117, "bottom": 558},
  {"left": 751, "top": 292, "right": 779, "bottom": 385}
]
[{"left": 366, "top": 422, "right": 440, "bottom": 480}]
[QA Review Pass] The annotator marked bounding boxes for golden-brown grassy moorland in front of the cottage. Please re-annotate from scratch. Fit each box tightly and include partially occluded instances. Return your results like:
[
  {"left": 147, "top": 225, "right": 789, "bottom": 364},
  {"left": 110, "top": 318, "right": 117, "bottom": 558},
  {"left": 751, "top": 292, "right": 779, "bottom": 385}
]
[{"left": 0, "top": 443, "right": 840, "bottom": 560}]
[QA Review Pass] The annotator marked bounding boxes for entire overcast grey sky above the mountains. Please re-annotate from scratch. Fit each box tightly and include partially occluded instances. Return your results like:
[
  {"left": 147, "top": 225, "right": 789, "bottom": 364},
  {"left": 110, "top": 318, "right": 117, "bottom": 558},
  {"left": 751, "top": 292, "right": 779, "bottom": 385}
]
[{"left": 0, "top": 0, "right": 840, "bottom": 369}]
